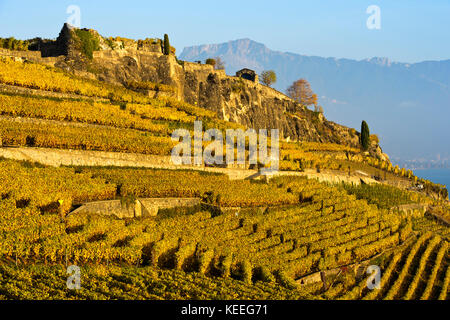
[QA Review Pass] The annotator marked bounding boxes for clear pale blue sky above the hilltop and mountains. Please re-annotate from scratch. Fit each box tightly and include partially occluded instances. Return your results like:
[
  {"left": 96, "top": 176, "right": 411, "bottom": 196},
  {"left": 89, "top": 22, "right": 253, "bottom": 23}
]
[{"left": 0, "top": 0, "right": 450, "bottom": 62}]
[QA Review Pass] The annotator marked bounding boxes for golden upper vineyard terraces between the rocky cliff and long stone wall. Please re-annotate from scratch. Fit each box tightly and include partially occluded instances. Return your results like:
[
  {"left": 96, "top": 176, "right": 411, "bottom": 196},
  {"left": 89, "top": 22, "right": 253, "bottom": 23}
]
[{"left": 0, "top": 58, "right": 436, "bottom": 179}]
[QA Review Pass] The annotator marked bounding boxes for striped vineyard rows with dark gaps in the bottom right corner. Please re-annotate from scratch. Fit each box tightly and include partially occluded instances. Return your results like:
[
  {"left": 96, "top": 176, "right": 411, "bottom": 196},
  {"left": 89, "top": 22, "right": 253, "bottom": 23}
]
[{"left": 328, "top": 232, "right": 450, "bottom": 300}]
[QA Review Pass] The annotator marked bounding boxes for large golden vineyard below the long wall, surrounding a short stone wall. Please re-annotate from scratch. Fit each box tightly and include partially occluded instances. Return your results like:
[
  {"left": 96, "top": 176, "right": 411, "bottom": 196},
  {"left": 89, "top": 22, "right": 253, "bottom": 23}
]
[{"left": 1, "top": 161, "right": 416, "bottom": 298}]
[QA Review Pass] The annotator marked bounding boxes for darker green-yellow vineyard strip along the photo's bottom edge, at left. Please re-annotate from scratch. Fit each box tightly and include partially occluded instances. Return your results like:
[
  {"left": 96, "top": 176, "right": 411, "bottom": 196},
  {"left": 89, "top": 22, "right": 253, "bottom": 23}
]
[{"left": 0, "top": 265, "right": 317, "bottom": 300}]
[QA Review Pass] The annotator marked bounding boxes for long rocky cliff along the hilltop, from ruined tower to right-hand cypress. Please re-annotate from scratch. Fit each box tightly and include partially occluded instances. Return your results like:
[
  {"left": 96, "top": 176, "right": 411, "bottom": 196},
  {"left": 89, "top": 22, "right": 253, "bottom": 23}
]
[{"left": 22, "top": 25, "right": 382, "bottom": 152}]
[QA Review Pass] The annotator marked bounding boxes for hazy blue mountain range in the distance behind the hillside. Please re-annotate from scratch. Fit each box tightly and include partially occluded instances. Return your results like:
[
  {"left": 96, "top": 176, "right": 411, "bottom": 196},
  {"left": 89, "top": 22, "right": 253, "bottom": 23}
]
[{"left": 180, "top": 39, "right": 450, "bottom": 164}]
